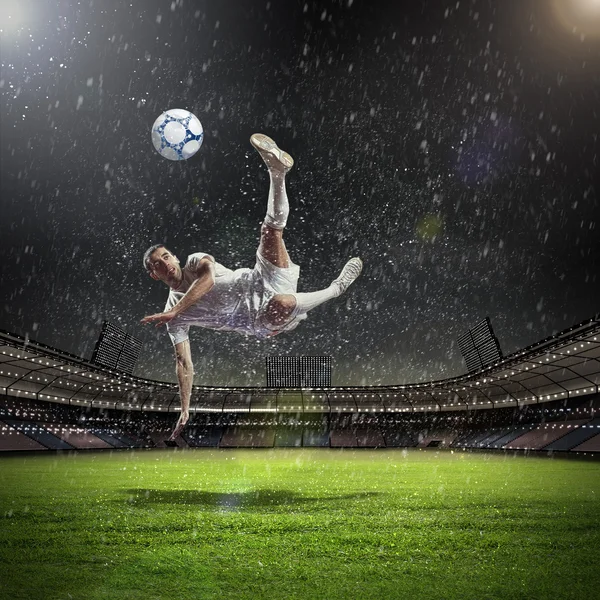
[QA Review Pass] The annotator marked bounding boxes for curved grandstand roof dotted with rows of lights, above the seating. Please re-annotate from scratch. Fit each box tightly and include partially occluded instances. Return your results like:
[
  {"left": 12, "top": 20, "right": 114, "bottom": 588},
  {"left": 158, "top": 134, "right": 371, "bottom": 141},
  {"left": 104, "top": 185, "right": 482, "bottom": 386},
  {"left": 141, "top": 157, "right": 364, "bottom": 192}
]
[{"left": 0, "top": 315, "right": 600, "bottom": 413}]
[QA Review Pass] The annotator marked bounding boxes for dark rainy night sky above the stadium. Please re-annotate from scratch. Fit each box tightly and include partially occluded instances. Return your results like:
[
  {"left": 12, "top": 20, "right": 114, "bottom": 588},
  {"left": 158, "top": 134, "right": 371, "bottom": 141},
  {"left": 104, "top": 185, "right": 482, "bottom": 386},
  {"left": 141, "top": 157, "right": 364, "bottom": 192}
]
[{"left": 0, "top": 0, "right": 600, "bottom": 385}]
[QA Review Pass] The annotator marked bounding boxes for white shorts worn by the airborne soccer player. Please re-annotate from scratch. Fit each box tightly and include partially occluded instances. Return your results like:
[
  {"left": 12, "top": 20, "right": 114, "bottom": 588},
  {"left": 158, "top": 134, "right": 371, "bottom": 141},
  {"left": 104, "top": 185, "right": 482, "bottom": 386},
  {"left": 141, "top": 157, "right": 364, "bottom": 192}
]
[{"left": 254, "top": 252, "right": 307, "bottom": 339}]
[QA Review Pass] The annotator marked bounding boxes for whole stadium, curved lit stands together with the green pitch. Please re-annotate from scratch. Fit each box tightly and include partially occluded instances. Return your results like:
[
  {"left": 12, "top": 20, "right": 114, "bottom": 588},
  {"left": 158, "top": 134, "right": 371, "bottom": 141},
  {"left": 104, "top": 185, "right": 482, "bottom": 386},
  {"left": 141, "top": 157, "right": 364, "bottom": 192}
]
[{"left": 0, "top": 318, "right": 600, "bottom": 598}]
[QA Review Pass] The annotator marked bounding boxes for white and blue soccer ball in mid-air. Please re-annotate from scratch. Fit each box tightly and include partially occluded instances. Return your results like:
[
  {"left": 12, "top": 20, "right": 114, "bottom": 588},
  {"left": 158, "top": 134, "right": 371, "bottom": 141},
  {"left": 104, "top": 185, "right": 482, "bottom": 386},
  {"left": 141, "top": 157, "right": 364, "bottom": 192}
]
[{"left": 152, "top": 108, "right": 204, "bottom": 160}]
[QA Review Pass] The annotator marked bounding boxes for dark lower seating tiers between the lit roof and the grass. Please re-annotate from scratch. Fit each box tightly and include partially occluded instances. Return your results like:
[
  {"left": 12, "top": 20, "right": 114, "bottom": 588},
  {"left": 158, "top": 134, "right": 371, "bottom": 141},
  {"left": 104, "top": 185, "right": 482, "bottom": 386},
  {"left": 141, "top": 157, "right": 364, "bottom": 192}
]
[{"left": 0, "top": 396, "right": 600, "bottom": 453}]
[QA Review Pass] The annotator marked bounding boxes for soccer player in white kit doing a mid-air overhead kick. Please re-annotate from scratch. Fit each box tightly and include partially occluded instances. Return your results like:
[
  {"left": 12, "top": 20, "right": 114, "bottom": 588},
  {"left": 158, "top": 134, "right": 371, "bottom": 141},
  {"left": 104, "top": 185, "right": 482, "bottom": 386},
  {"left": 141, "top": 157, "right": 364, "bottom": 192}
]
[{"left": 141, "top": 133, "right": 362, "bottom": 440}]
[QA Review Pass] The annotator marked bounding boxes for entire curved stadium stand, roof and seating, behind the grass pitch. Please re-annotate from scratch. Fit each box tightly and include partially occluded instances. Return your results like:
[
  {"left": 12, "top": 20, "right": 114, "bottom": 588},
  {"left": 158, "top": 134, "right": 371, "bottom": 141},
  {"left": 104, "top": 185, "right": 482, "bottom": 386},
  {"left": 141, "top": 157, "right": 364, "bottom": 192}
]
[{"left": 0, "top": 319, "right": 600, "bottom": 453}]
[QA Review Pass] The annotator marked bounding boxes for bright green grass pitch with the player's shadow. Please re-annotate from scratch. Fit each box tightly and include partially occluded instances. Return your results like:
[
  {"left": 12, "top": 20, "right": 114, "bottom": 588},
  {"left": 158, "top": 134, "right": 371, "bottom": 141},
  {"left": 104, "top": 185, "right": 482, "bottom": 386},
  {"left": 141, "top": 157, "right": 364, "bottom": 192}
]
[{"left": 0, "top": 449, "right": 600, "bottom": 600}]
